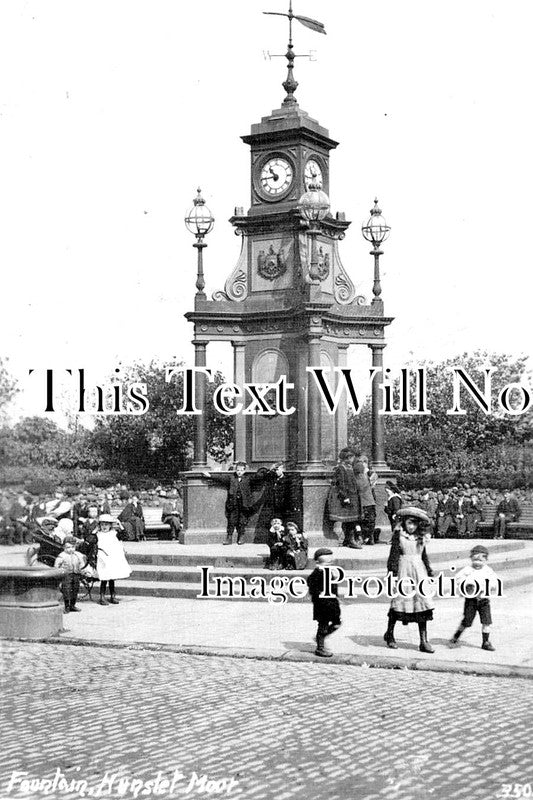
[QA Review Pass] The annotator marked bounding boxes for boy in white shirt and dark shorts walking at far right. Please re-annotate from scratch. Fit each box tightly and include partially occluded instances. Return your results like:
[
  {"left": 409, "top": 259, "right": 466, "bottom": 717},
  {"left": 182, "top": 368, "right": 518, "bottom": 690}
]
[{"left": 448, "top": 544, "right": 498, "bottom": 650}]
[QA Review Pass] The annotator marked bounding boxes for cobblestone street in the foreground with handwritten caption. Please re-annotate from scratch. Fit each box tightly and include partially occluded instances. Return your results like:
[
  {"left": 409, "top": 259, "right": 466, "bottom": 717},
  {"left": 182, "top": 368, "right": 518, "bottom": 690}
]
[{"left": 0, "top": 642, "right": 533, "bottom": 800}]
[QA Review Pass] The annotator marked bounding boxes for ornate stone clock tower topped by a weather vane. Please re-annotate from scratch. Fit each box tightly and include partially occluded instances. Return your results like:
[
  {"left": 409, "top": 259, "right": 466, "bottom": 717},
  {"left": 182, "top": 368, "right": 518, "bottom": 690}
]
[{"left": 181, "top": 11, "right": 391, "bottom": 541}]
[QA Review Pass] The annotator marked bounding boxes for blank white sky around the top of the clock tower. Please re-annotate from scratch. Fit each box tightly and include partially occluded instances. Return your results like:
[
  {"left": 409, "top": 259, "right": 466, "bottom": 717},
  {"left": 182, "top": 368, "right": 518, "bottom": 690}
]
[{"left": 0, "top": 0, "right": 533, "bottom": 422}]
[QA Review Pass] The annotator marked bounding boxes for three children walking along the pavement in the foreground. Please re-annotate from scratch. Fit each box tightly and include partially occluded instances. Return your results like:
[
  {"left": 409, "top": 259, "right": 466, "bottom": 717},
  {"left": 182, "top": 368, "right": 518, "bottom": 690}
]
[{"left": 307, "top": 506, "right": 496, "bottom": 658}]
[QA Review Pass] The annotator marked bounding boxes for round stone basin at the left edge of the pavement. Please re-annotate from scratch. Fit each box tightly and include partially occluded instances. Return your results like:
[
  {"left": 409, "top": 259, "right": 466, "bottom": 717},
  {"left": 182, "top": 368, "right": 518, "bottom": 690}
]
[{"left": 0, "top": 566, "right": 63, "bottom": 639}]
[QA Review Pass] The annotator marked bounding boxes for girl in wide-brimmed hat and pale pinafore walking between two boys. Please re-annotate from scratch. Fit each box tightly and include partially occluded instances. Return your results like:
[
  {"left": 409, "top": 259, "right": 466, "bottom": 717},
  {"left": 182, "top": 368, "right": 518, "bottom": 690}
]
[{"left": 383, "top": 506, "right": 435, "bottom": 653}]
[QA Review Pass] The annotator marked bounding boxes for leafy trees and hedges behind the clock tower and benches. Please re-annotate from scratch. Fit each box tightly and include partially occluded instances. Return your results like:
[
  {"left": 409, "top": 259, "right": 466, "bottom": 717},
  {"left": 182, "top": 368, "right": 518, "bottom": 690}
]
[{"left": 0, "top": 352, "right": 533, "bottom": 489}]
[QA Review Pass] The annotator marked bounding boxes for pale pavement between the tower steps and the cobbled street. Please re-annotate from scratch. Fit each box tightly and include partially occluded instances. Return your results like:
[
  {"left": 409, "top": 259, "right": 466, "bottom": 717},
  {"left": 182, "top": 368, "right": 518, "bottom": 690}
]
[{"left": 0, "top": 541, "right": 533, "bottom": 677}]
